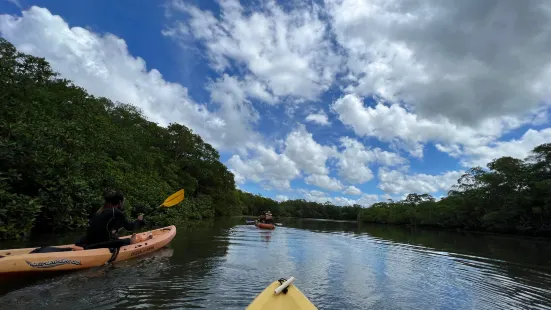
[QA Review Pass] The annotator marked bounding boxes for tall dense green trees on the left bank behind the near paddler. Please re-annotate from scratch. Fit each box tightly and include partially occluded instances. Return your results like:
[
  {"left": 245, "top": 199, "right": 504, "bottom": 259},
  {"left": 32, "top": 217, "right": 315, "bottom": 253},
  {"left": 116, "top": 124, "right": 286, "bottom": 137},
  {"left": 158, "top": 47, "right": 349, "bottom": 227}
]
[{"left": 0, "top": 39, "right": 237, "bottom": 239}]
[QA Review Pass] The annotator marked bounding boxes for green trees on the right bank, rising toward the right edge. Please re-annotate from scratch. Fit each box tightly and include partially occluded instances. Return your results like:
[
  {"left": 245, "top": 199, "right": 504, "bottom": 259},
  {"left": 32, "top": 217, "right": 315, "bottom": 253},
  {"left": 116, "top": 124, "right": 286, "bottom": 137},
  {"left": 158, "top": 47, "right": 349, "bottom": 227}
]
[{"left": 360, "top": 147, "right": 551, "bottom": 235}]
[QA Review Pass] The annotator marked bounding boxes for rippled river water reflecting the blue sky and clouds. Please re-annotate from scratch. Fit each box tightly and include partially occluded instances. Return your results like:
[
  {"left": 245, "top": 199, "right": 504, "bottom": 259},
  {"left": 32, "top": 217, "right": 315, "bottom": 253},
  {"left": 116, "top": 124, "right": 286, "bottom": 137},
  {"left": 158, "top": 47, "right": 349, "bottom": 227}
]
[{"left": 0, "top": 218, "right": 551, "bottom": 309}]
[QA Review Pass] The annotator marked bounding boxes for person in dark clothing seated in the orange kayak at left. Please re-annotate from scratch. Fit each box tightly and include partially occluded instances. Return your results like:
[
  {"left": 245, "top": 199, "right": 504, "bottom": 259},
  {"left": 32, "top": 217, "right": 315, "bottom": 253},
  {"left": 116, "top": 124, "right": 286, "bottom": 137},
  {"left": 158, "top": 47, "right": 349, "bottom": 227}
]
[{"left": 76, "top": 191, "right": 151, "bottom": 248}]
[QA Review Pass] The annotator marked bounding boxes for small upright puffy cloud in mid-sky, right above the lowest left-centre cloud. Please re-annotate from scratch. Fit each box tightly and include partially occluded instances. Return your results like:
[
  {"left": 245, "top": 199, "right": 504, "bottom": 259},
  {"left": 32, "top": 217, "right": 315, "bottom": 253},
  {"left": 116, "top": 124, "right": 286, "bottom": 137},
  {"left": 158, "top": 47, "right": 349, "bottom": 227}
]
[{"left": 284, "top": 125, "right": 336, "bottom": 174}]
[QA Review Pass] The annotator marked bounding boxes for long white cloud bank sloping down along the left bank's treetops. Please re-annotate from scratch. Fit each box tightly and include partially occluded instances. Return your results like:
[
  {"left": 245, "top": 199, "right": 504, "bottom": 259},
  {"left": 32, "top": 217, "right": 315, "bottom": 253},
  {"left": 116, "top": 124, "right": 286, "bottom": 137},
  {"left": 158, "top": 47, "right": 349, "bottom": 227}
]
[{"left": 0, "top": 6, "right": 257, "bottom": 149}]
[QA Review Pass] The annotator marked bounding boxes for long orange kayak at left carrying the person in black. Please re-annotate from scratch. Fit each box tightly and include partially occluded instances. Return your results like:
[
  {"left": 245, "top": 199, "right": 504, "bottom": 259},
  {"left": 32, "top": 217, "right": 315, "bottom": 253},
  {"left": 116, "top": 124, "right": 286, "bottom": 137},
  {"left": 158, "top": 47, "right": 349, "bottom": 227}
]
[{"left": 0, "top": 226, "right": 176, "bottom": 276}]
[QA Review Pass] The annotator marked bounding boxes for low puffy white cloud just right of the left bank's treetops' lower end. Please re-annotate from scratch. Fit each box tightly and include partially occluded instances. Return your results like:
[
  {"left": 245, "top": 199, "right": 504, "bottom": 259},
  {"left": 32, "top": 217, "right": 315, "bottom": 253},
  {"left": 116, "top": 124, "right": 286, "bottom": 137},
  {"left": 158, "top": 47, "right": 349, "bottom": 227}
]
[{"left": 227, "top": 145, "right": 300, "bottom": 189}]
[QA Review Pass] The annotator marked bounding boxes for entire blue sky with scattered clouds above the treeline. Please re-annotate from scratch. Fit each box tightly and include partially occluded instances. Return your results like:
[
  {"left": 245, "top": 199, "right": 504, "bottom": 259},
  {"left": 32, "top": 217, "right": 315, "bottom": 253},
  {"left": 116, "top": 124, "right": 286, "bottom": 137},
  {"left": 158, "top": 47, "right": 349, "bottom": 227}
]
[{"left": 0, "top": 0, "right": 551, "bottom": 206}]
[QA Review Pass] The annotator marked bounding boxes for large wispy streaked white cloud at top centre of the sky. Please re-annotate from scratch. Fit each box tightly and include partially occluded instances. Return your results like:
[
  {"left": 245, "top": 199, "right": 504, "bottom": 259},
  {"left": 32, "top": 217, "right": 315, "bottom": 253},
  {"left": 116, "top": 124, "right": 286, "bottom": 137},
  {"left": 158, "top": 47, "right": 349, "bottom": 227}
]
[{"left": 164, "top": 0, "right": 340, "bottom": 100}]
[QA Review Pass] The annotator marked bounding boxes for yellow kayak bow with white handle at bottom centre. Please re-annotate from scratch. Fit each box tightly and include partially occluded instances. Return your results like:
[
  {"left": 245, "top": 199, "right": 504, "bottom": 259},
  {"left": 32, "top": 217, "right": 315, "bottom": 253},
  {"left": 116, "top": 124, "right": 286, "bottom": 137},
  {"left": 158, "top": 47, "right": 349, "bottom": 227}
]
[{"left": 247, "top": 277, "right": 317, "bottom": 310}]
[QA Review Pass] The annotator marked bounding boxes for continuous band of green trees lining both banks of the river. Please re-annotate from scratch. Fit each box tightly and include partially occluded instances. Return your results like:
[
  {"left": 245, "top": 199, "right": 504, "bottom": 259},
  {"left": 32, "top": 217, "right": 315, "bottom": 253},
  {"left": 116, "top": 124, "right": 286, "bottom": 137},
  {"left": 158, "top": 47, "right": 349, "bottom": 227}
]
[{"left": 0, "top": 38, "right": 551, "bottom": 239}]
